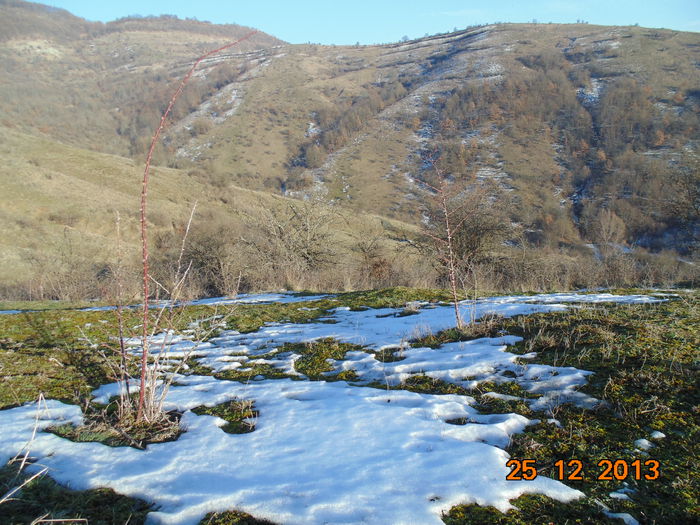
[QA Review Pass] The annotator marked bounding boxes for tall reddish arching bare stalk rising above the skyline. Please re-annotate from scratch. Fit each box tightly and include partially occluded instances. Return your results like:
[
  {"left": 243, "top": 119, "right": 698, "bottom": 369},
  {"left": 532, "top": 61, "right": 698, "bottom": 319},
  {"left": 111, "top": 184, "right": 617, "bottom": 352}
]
[{"left": 136, "top": 31, "right": 257, "bottom": 421}]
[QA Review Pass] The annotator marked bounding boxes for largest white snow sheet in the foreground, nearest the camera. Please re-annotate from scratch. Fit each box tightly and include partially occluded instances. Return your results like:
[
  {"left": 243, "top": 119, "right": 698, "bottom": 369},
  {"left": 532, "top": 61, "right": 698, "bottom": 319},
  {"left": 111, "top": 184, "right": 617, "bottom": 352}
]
[{"left": 0, "top": 376, "right": 582, "bottom": 524}]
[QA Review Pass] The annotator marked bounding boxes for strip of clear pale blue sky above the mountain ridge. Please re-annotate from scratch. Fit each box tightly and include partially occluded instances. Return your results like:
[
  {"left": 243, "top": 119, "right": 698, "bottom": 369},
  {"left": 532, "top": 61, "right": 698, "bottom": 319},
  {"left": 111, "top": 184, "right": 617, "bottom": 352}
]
[{"left": 44, "top": 0, "right": 700, "bottom": 44}]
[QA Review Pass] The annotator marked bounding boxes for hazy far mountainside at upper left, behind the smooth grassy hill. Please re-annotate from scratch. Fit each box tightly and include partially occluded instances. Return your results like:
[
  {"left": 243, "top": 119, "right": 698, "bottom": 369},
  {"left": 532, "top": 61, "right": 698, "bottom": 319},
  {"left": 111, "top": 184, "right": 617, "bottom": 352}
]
[{"left": 0, "top": 1, "right": 283, "bottom": 154}]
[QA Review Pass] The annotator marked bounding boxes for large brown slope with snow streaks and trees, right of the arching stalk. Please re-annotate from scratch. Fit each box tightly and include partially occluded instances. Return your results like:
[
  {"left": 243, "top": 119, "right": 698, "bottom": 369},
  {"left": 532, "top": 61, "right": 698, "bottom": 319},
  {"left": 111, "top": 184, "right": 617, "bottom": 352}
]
[{"left": 133, "top": 24, "right": 700, "bottom": 253}]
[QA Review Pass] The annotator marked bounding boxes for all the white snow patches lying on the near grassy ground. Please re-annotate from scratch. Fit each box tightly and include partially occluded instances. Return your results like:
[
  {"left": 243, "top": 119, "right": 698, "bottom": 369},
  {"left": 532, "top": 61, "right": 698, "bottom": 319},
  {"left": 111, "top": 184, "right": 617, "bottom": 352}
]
[{"left": 0, "top": 294, "right": 660, "bottom": 524}]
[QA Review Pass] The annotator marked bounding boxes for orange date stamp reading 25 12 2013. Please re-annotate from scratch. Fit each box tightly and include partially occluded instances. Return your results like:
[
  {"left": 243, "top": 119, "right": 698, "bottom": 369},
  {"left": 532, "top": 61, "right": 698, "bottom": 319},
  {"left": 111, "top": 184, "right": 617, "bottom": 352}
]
[{"left": 506, "top": 459, "right": 661, "bottom": 481}]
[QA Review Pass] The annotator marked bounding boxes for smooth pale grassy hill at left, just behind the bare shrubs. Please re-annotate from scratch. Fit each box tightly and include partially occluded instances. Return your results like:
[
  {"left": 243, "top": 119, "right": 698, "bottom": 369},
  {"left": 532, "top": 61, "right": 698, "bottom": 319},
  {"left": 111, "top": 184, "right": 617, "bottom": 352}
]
[{"left": 0, "top": 124, "right": 412, "bottom": 295}]
